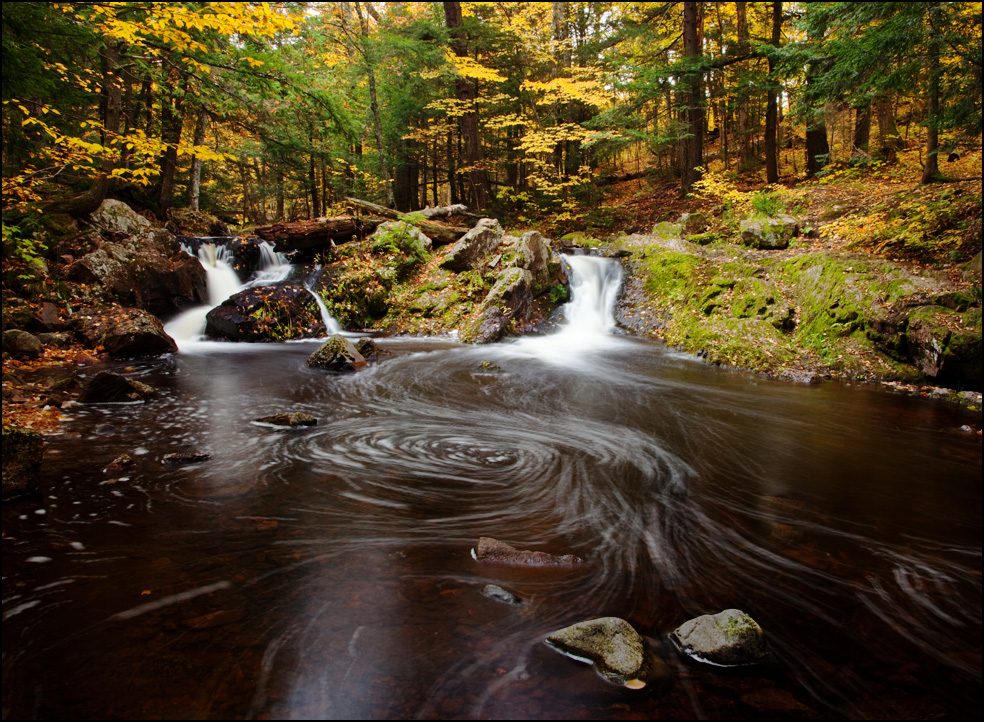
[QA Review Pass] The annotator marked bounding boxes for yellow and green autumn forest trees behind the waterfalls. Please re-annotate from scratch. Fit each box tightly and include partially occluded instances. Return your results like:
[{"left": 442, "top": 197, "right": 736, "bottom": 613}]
[{"left": 2, "top": 2, "right": 981, "bottom": 236}]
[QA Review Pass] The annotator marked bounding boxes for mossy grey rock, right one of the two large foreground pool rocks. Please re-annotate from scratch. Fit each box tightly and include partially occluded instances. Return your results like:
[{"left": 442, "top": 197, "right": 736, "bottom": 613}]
[{"left": 670, "top": 609, "right": 769, "bottom": 667}]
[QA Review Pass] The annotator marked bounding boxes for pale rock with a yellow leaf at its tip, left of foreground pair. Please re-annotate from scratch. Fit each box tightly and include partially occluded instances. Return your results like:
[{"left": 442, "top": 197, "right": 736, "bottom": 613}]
[{"left": 546, "top": 617, "right": 649, "bottom": 688}]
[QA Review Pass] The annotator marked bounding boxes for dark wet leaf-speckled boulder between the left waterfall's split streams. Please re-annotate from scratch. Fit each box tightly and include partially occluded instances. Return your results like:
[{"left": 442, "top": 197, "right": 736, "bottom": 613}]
[{"left": 205, "top": 281, "right": 327, "bottom": 341}]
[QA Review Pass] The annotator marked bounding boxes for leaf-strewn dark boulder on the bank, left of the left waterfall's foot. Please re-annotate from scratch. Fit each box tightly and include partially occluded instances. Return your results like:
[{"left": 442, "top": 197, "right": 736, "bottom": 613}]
[{"left": 77, "top": 307, "right": 178, "bottom": 358}]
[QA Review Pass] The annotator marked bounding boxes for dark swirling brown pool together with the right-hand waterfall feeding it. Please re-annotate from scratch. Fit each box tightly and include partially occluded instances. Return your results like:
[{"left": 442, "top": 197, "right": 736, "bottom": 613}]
[{"left": 3, "top": 258, "right": 981, "bottom": 719}]
